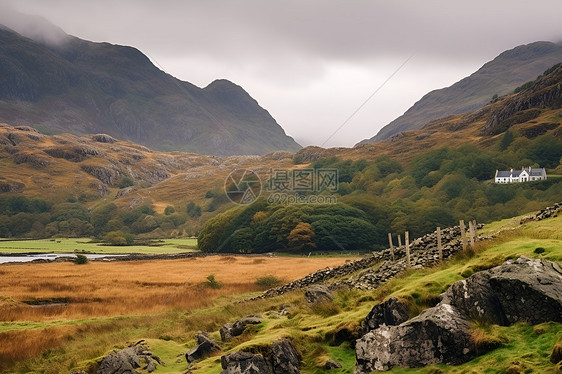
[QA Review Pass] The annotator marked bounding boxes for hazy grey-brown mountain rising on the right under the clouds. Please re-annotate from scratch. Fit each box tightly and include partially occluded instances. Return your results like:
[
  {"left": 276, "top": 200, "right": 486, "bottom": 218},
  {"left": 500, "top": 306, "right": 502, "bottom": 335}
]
[{"left": 358, "top": 42, "right": 562, "bottom": 144}]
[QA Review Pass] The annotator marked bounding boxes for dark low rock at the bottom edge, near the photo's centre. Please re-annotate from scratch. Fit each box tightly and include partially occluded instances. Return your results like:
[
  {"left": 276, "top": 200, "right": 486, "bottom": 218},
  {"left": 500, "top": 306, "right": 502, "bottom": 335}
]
[{"left": 221, "top": 339, "right": 301, "bottom": 374}]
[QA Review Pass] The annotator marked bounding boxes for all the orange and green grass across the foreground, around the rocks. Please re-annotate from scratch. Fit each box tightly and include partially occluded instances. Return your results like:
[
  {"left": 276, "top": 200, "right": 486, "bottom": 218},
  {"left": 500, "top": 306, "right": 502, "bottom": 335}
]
[{"left": 0, "top": 212, "right": 562, "bottom": 374}]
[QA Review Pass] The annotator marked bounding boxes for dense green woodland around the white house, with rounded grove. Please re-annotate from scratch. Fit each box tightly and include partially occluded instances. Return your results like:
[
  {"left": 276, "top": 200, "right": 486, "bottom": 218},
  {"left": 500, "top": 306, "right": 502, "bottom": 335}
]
[{"left": 199, "top": 132, "right": 562, "bottom": 253}]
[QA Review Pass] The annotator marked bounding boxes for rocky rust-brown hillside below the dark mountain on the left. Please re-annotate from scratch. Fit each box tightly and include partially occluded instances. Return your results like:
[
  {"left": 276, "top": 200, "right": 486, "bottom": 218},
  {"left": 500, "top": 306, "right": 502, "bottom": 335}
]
[{"left": 0, "top": 124, "right": 292, "bottom": 211}]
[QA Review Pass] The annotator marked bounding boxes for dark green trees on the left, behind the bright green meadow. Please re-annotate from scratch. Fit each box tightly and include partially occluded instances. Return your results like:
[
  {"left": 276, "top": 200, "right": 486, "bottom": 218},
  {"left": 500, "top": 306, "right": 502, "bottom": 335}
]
[{"left": 0, "top": 195, "right": 201, "bottom": 240}]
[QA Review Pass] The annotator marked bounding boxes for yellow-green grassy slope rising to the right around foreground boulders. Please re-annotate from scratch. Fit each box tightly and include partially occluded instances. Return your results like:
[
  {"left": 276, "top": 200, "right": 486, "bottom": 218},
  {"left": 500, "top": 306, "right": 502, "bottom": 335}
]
[{"left": 4, "top": 212, "right": 562, "bottom": 373}]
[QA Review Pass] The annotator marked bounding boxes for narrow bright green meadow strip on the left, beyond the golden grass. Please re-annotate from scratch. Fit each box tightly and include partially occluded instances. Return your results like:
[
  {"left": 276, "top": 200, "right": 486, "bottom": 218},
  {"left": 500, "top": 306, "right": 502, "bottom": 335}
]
[{"left": 0, "top": 238, "right": 197, "bottom": 254}]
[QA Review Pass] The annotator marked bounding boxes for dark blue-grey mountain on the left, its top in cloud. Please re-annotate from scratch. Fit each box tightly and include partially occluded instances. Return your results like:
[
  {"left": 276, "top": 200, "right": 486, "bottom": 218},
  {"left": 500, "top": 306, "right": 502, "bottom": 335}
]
[{"left": 0, "top": 21, "right": 300, "bottom": 156}]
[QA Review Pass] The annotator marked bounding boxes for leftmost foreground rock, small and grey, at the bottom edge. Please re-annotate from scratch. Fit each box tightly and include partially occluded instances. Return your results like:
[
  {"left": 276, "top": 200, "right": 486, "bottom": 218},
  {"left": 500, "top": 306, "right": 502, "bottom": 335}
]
[{"left": 96, "top": 342, "right": 163, "bottom": 374}]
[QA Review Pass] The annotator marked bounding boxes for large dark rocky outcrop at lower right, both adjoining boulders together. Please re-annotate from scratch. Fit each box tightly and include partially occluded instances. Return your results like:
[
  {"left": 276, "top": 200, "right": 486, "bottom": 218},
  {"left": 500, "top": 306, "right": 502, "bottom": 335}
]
[{"left": 355, "top": 256, "right": 562, "bottom": 374}]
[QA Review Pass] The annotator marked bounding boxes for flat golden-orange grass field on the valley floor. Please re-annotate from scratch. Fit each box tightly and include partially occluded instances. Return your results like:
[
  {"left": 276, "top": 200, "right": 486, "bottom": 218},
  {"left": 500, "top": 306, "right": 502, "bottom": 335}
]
[{"left": 0, "top": 256, "right": 354, "bottom": 321}]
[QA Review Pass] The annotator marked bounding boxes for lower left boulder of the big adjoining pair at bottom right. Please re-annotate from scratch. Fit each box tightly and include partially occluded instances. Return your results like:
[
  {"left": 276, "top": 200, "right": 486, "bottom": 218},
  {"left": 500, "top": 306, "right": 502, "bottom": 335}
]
[{"left": 355, "top": 303, "right": 475, "bottom": 374}]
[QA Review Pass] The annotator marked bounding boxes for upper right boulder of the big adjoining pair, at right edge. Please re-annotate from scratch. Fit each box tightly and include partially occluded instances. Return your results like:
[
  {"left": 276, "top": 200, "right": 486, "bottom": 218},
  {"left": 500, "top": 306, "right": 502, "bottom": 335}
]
[{"left": 443, "top": 256, "right": 562, "bottom": 325}]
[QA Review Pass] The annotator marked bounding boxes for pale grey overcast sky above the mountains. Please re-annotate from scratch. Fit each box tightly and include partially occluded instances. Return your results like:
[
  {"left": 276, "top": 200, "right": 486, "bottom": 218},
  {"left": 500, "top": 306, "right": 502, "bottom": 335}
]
[{"left": 0, "top": 0, "right": 562, "bottom": 146}]
